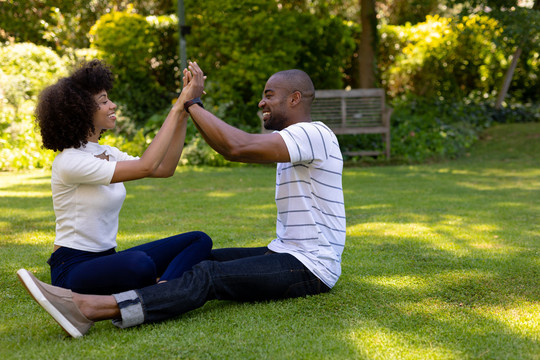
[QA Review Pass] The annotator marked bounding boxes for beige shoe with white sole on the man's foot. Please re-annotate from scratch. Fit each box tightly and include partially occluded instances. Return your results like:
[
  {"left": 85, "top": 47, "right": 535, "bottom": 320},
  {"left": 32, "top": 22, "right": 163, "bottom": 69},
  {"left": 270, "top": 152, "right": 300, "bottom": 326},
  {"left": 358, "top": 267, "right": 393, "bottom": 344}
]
[{"left": 17, "top": 269, "right": 94, "bottom": 338}]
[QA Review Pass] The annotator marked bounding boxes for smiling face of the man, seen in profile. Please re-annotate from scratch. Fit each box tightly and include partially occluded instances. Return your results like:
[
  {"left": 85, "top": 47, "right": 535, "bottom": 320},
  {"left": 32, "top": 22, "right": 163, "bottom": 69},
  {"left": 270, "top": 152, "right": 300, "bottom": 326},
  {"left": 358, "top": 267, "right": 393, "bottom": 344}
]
[{"left": 259, "top": 76, "right": 289, "bottom": 130}]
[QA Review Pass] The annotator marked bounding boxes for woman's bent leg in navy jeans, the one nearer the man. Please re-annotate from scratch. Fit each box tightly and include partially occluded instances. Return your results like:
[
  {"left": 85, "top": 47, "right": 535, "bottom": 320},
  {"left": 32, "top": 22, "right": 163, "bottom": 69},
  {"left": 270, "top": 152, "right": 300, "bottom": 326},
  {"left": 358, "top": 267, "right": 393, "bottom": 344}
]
[{"left": 120, "top": 231, "right": 212, "bottom": 282}]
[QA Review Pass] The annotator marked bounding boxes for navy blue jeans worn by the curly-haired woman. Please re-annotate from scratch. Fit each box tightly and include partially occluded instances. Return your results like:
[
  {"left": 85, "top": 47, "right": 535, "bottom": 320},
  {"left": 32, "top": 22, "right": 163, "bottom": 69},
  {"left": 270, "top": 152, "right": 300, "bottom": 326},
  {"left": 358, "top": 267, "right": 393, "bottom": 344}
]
[{"left": 47, "top": 231, "right": 212, "bottom": 295}]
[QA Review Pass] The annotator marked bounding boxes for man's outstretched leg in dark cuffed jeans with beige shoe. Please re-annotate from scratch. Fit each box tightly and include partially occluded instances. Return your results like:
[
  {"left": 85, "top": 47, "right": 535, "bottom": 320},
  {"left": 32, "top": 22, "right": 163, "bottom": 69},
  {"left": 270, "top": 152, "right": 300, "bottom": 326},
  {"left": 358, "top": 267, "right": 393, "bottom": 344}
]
[{"left": 17, "top": 253, "right": 330, "bottom": 337}]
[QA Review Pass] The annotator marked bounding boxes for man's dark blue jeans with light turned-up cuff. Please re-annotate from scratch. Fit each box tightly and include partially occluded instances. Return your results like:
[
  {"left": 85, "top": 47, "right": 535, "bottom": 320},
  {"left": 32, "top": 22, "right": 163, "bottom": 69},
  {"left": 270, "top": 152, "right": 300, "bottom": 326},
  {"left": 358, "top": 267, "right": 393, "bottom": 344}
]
[{"left": 114, "top": 247, "right": 330, "bottom": 327}]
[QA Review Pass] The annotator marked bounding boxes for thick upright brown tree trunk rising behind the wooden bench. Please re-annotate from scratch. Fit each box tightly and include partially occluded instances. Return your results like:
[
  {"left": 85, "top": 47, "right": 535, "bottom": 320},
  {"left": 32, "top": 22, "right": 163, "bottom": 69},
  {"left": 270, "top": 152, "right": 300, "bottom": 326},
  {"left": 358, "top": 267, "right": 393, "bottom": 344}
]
[{"left": 357, "top": 0, "right": 377, "bottom": 89}]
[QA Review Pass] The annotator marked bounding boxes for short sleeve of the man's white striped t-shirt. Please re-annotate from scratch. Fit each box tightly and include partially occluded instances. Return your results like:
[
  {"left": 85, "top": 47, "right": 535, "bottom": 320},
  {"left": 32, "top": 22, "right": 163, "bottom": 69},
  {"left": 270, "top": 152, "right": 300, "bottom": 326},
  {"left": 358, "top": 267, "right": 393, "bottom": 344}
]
[{"left": 279, "top": 122, "right": 332, "bottom": 164}]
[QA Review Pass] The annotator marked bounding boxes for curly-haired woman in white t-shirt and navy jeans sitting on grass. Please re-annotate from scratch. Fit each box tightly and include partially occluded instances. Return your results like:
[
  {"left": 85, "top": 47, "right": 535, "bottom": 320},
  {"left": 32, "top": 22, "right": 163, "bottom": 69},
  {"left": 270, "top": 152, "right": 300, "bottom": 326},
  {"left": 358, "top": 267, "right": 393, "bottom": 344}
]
[{"left": 36, "top": 60, "right": 212, "bottom": 294}]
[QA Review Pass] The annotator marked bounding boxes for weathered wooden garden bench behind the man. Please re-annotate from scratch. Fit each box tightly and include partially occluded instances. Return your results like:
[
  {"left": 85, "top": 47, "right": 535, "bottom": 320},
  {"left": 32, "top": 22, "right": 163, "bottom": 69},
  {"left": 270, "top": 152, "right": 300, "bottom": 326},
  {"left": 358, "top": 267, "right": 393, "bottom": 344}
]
[{"left": 259, "top": 89, "right": 392, "bottom": 159}]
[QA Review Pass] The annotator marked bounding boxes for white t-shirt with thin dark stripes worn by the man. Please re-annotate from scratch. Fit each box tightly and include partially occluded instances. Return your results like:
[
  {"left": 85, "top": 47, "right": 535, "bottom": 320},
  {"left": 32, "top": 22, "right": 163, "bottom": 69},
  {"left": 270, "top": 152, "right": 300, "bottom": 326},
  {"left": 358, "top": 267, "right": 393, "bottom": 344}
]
[{"left": 268, "top": 121, "right": 346, "bottom": 287}]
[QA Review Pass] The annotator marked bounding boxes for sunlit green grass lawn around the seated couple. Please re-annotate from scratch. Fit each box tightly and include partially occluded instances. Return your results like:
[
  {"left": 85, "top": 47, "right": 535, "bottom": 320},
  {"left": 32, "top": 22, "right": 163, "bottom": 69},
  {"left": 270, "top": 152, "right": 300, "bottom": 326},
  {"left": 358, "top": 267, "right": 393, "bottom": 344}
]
[{"left": 0, "top": 123, "right": 540, "bottom": 359}]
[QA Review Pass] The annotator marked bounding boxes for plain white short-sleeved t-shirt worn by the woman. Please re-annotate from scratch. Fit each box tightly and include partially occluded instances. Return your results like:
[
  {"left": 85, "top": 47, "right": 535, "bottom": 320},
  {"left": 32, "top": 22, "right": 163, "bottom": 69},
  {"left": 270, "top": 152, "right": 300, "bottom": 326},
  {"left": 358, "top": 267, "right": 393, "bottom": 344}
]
[{"left": 51, "top": 142, "right": 138, "bottom": 252}]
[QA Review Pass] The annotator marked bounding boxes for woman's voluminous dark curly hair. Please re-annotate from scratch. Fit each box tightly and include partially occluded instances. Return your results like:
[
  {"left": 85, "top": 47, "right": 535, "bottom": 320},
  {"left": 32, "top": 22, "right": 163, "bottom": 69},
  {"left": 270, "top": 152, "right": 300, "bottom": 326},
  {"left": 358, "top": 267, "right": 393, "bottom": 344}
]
[{"left": 35, "top": 60, "right": 113, "bottom": 151}]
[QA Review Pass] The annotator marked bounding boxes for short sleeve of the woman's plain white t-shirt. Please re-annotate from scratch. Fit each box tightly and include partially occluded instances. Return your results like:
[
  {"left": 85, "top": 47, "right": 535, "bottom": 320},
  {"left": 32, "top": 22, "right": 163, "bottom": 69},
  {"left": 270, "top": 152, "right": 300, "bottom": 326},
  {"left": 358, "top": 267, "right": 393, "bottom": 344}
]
[{"left": 54, "top": 152, "right": 116, "bottom": 185}]
